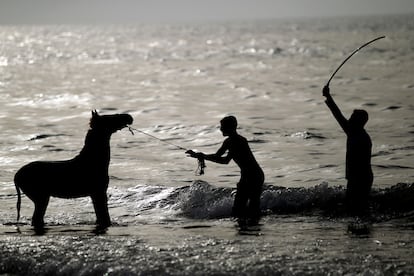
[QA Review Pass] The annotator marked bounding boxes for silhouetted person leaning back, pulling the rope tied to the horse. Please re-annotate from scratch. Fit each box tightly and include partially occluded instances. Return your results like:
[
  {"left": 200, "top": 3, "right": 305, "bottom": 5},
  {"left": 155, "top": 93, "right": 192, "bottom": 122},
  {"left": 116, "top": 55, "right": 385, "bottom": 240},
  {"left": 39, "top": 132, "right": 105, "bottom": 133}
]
[{"left": 187, "top": 116, "right": 264, "bottom": 224}]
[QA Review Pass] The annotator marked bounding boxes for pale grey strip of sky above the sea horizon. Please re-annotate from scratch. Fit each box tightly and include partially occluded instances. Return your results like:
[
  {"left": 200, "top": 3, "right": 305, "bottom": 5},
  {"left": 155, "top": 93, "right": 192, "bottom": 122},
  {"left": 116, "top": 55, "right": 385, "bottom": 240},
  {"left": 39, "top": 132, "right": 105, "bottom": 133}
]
[{"left": 0, "top": 0, "right": 414, "bottom": 24}]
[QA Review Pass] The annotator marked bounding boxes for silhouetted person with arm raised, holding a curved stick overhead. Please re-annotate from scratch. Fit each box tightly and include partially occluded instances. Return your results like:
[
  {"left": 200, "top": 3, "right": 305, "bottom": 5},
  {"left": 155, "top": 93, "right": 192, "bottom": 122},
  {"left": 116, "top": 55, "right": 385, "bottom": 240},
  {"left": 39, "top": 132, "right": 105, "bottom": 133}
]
[{"left": 322, "top": 86, "right": 374, "bottom": 214}]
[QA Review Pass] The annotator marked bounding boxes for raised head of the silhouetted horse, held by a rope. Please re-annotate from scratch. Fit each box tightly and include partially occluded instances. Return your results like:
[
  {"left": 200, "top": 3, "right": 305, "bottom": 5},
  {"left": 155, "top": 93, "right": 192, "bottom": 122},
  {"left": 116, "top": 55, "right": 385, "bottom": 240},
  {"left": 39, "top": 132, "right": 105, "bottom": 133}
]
[{"left": 89, "top": 110, "right": 134, "bottom": 134}]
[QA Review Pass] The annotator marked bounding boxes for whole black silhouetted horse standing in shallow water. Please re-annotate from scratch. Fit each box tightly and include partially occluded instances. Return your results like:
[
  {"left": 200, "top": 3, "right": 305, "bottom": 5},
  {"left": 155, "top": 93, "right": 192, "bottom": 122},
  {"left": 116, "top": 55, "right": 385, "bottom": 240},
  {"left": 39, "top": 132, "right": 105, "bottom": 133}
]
[{"left": 14, "top": 110, "right": 133, "bottom": 229}]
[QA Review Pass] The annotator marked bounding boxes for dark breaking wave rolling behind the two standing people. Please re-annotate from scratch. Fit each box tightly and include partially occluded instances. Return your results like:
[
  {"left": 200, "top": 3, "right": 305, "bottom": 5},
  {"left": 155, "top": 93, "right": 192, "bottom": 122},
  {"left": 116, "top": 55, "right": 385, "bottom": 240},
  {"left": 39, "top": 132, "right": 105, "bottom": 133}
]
[{"left": 114, "top": 180, "right": 414, "bottom": 220}]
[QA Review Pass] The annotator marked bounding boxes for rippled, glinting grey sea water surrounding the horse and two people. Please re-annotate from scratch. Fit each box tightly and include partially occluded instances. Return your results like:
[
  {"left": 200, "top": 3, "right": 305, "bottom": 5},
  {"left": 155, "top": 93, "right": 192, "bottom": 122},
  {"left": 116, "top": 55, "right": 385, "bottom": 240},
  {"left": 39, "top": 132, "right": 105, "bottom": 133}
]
[{"left": 0, "top": 15, "right": 414, "bottom": 275}]
